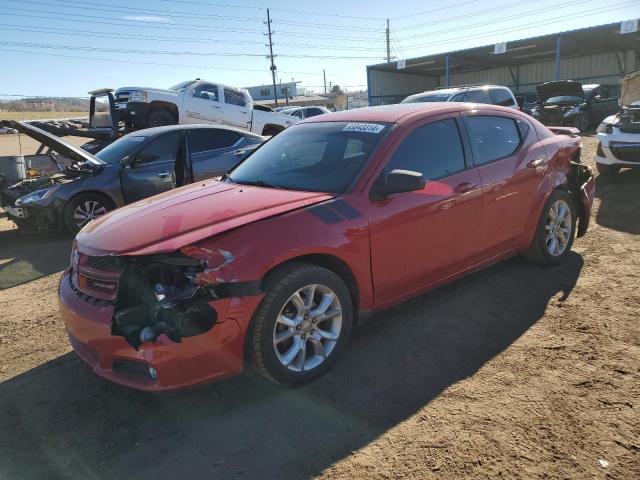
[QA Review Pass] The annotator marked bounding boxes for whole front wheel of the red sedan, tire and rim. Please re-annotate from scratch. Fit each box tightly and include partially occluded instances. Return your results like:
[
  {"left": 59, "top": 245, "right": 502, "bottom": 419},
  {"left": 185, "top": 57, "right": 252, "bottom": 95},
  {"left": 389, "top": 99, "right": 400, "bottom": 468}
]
[{"left": 248, "top": 263, "right": 353, "bottom": 386}]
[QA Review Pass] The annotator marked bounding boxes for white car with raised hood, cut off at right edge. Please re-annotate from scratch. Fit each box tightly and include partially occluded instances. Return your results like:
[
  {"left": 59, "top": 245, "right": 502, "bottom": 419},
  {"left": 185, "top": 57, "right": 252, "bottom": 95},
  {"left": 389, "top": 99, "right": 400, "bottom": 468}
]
[{"left": 595, "top": 70, "right": 640, "bottom": 174}]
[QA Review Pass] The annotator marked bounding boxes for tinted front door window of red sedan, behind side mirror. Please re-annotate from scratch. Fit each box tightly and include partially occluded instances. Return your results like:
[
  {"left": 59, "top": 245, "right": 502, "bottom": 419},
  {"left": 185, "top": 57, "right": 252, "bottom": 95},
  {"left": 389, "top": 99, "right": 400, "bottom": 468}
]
[{"left": 385, "top": 118, "right": 465, "bottom": 180}]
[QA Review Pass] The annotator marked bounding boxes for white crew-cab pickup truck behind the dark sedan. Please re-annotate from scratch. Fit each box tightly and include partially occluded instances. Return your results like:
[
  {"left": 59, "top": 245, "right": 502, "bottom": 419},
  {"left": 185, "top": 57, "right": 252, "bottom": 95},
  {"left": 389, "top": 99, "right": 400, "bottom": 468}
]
[{"left": 115, "top": 78, "right": 297, "bottom": 136}]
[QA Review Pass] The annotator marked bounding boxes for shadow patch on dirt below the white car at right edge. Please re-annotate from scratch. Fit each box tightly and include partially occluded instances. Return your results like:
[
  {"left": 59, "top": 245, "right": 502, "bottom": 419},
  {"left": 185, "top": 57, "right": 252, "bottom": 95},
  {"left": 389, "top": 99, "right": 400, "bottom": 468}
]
[{"left": 596, "top": 169, "right": 640, "bottom": 235}]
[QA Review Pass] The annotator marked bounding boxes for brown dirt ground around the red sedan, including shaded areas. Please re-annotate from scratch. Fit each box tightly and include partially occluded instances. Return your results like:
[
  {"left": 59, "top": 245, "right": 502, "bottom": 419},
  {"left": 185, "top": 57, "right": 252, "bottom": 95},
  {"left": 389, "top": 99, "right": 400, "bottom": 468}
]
[{"left": 0, "top": 138, "right": 640, "bottom": 479}]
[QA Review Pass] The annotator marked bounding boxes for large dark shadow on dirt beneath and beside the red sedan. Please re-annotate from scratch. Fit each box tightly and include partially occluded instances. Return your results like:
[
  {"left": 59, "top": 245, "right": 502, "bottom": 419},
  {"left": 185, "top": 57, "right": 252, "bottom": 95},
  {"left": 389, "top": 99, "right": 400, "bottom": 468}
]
[{"left": 0, "top": 253, "right": 582, "bottom": 479}]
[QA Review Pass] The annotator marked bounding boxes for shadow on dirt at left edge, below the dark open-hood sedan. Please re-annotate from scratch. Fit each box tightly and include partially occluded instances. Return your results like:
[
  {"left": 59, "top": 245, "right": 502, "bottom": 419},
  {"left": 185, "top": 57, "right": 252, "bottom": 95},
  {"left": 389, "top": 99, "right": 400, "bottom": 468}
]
[{"left": 0, "top": 228, "right": 73, "bottom": 290}]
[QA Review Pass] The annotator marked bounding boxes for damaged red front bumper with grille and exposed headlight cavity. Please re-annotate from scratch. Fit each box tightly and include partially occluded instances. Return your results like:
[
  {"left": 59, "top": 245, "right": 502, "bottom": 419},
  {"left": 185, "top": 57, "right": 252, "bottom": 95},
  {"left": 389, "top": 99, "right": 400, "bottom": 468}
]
[{"left": 59, "top": 251, "right": 263, "bottom": 390}]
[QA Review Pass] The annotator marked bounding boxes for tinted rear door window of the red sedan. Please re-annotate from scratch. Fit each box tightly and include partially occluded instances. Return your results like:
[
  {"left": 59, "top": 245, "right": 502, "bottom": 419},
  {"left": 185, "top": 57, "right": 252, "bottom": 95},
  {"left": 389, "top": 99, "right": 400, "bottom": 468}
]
[{"left": 465, "top": 115, "right": 526, "bottom": 165}]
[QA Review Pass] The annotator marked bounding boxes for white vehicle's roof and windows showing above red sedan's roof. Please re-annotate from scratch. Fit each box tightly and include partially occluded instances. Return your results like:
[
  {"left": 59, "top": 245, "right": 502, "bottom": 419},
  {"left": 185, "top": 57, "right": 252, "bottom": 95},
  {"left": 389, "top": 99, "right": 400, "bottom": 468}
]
[{"left": 400, "top": 85, "right": 518, "bottom": 108}]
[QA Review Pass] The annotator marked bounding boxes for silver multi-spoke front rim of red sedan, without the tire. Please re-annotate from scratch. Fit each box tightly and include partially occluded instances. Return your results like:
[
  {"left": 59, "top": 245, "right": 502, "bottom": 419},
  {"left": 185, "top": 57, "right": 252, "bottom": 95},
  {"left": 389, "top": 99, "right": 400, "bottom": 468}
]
[{"left": 273, "top": 284, "right": 342, "bottom": 372}]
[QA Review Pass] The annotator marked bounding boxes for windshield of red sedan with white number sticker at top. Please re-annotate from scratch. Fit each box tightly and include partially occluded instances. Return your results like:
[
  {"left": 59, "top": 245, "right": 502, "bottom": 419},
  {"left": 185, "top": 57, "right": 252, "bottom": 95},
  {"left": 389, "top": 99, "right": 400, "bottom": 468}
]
[{"left": 228, "top": 122, "right": 390, "bottom": 193}]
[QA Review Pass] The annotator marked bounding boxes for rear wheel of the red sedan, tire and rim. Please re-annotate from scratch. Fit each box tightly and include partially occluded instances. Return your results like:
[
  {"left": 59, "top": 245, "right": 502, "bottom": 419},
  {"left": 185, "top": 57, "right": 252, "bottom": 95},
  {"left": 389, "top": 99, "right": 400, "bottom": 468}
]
[{"left": 522, "top": 190, "right": 577, "bottom": 265}]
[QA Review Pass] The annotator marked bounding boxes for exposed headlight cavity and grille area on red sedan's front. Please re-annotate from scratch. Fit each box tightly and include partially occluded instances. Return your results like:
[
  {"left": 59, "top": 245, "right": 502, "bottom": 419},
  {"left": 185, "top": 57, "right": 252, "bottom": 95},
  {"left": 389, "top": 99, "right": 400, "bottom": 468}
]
[{"left": 71, "top": 247, "right": 260, "bottom": 350}]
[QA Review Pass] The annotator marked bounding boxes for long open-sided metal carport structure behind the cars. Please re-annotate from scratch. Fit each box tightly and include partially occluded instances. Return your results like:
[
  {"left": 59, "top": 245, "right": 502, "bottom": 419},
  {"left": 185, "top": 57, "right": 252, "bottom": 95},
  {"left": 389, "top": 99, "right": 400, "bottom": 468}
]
[{"left": 367, "top": 23, "right": 640, "bottom": 105}]
